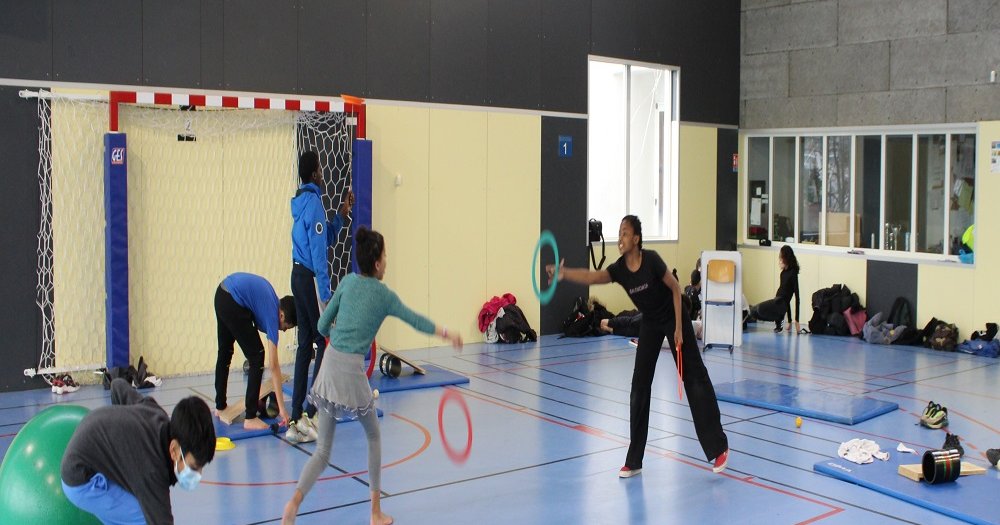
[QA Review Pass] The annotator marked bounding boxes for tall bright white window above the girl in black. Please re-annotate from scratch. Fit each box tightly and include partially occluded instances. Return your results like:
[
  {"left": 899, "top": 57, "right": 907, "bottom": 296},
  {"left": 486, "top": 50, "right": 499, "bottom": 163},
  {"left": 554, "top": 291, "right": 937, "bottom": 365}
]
[{"left": 587, "top": 58, "right": 679, "bottom": 240}]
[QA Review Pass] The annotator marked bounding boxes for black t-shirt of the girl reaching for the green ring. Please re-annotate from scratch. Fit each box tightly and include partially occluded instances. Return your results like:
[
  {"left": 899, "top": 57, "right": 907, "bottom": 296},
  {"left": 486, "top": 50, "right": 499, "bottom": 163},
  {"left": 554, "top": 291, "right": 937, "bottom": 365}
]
[{"left": 608, "top": 250, "right": 674, "bottom": 323}]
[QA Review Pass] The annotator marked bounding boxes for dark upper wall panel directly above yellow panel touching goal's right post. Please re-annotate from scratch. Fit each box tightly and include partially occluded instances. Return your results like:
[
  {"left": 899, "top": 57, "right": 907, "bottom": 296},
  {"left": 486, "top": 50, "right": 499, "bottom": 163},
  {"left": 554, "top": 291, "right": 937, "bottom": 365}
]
[{"left": 366, "top": 0, "right": 431, "bottom": 101}]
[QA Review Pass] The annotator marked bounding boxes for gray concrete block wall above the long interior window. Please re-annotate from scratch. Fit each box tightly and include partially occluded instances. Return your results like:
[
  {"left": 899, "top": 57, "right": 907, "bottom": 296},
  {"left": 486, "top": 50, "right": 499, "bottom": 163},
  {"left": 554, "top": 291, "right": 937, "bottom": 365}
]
[{"left": 740, "top": 0, "right": 1000, "bottom": 130}]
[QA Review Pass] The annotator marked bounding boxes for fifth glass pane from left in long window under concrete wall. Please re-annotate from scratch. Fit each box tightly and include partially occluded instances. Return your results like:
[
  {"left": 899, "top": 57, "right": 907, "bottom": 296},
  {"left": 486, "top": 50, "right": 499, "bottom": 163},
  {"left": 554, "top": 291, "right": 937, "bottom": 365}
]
[{"left": 854, "top": 135, "right": 882, "bottom": 250}]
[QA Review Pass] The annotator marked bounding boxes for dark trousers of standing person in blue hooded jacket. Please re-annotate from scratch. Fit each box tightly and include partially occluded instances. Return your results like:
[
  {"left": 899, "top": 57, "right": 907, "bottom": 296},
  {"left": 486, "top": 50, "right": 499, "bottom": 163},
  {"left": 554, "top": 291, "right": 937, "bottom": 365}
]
[{"left": 292, "top": 264, "right": 326, "bottom": 421}]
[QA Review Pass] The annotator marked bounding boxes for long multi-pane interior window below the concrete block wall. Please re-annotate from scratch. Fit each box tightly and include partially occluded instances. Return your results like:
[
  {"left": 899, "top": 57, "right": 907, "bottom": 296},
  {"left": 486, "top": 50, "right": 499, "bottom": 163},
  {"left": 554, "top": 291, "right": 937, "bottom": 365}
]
[{"left": 745, "top": 126, "right": 976, "bottom": 255}]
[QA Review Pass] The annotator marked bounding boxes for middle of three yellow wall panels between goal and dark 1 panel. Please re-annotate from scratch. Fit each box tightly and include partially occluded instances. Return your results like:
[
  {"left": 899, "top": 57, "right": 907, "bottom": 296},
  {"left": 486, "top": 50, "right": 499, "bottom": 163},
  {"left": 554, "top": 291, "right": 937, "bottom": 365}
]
[{"left": 428, "top": 110, "right": 488, "bottom": 341}]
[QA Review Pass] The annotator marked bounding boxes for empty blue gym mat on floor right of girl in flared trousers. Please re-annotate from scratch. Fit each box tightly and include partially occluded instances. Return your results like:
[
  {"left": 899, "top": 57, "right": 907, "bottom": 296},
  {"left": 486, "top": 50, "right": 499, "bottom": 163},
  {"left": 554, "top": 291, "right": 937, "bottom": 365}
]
[{"left": 715, "top": 379, "right": 899, "bottom": 425}]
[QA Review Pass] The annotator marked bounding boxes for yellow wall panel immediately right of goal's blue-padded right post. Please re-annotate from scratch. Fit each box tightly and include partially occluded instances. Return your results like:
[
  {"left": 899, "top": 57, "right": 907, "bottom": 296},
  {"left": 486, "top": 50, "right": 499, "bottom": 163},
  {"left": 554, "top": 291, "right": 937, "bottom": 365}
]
[{"left": 366, "top": 105, "right": 431, "bottom": 349}]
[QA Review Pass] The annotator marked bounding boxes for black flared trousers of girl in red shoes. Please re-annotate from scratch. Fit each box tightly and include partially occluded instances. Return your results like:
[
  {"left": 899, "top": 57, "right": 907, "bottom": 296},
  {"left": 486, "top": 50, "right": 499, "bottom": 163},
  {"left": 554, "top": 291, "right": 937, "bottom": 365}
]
[{"left": 625, "top": 312, "right": 729, "bottom": 469}]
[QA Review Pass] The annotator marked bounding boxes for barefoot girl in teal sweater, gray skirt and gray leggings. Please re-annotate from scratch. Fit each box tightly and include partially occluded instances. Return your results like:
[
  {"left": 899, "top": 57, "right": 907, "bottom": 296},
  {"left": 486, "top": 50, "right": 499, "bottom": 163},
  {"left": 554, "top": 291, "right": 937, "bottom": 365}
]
[{"left": 282, "top": 226, "right": 462, "bottom": 525}]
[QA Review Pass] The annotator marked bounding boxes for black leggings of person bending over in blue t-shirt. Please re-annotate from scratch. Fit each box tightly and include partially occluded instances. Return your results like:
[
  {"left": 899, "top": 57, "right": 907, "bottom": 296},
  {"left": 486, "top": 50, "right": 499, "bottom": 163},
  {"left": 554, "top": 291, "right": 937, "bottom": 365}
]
[{"left": 215, "top": 285, "right": 264, "bottom": 419}]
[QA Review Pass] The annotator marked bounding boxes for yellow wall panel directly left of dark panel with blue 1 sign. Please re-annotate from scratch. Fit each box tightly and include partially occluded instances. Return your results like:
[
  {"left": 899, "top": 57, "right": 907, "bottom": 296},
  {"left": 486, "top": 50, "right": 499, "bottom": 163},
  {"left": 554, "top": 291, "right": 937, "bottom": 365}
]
[{"left": 484, "top": 113, "right": 543, "bottom": 330}]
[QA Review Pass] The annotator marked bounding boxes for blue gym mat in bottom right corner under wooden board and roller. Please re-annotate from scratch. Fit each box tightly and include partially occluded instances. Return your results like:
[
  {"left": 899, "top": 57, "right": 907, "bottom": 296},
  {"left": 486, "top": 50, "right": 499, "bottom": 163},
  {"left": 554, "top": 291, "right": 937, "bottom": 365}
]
[{"left": 813, "top": 452, "right": 1000, "bottom": 525}]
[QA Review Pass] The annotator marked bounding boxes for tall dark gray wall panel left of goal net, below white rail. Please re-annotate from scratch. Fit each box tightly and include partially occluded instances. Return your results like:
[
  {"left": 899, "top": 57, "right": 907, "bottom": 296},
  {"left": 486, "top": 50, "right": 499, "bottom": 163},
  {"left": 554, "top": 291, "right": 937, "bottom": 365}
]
[{"left": 0, "top": 87, "right": 45, "bottom": 391}]
